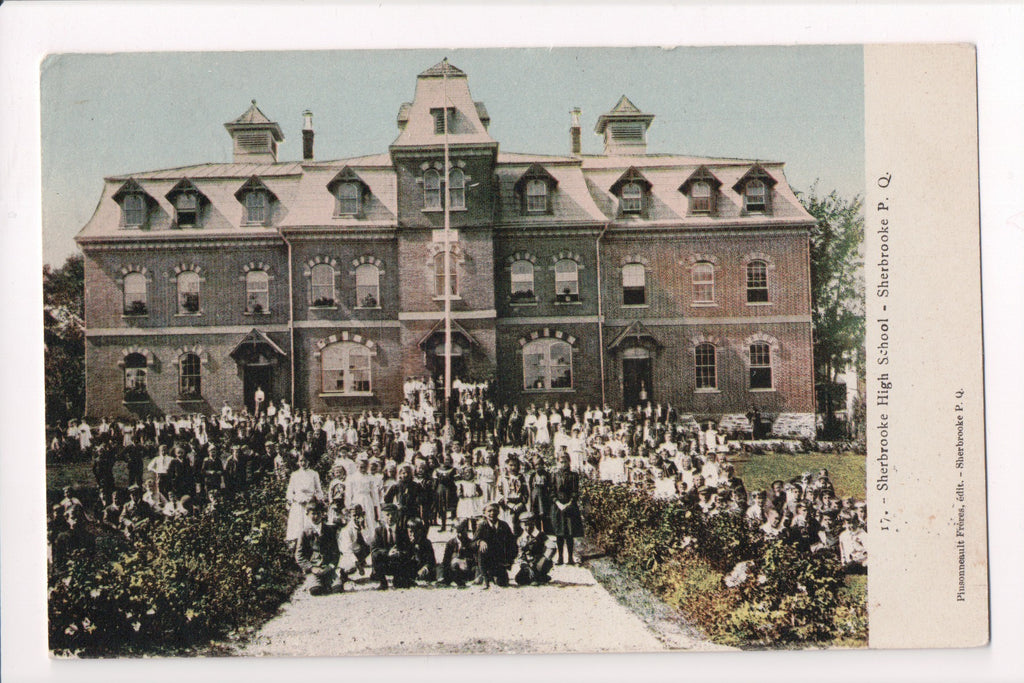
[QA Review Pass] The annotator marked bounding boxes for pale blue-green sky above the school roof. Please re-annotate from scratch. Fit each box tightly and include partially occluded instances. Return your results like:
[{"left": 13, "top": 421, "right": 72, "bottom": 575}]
[{"left": 40, "top": 46, "right": 864, "bottom": 265}]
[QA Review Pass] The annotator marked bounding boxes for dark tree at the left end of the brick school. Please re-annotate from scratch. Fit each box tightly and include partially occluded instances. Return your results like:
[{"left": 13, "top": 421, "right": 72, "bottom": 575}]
[{"left": 43, "top": 254, "right": 85, "bottom": 425}]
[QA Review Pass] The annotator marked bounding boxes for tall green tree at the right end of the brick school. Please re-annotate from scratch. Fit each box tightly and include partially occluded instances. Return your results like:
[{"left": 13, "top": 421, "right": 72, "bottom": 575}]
[{"left": 800, "top": 183, "right": 864, "bottom": 384}]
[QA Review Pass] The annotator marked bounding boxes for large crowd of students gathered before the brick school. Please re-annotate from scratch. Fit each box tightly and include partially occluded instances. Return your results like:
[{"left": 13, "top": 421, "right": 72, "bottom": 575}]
[{"left": 50, "top": 379, "right": 867, "bottom": 592}]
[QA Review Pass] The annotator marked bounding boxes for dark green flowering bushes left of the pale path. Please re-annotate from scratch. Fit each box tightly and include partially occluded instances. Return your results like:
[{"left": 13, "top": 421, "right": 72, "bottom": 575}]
[{"left": 48, "top": 481, "right": 299, "bottom": 656}]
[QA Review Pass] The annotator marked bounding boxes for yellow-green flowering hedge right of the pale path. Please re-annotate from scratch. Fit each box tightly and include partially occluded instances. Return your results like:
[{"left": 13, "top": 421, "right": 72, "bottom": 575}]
[{"left": 582, "top": 481, "right": 867, "bottom": 647}]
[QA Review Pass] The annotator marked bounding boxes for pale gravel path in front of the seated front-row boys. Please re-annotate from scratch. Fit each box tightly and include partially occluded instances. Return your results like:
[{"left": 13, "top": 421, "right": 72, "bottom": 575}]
[{"left": 237, "top": 529, "right": 717, "bottom": 656}]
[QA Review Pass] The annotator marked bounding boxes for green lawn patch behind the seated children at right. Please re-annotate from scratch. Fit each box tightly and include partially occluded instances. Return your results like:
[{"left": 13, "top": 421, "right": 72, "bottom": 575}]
[{"left": 729, "top": 453, "right": 867, "bottom": 500}]
